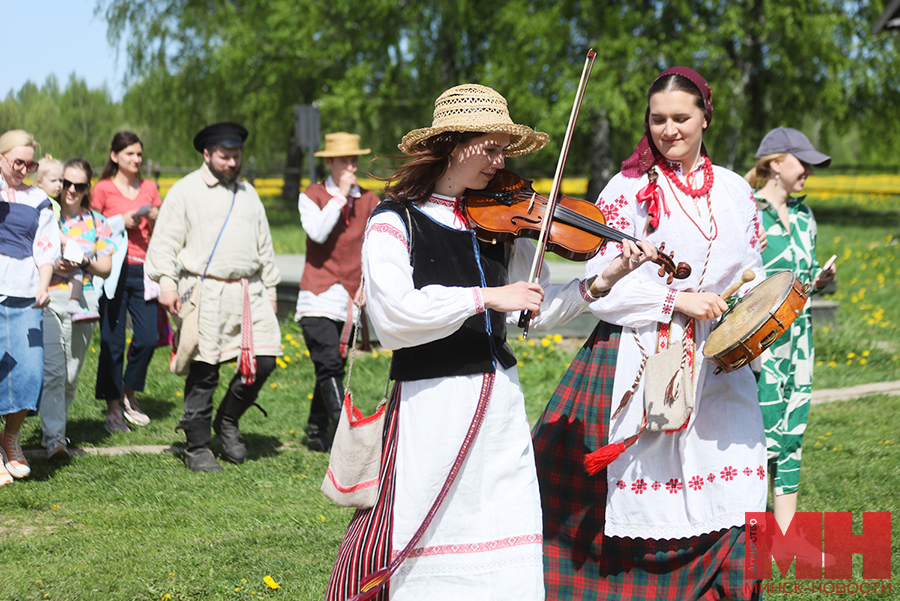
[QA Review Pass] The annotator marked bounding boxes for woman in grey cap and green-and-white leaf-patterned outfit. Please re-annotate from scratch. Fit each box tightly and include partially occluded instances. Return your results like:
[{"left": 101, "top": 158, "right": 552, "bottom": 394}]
[{"left": 746, "top": 127, "right": 835, "bottom": 531}]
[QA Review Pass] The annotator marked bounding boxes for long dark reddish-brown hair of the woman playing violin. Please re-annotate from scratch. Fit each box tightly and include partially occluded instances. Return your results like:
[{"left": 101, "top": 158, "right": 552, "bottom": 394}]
[{"left": 377, "top": 131, "right": 484, "bottom": 202}]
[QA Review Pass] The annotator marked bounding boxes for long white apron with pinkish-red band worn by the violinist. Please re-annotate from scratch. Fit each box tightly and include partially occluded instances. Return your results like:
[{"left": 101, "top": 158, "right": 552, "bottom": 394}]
[{"left": 390, "top": 367, "right": 544, "bottom": 601}]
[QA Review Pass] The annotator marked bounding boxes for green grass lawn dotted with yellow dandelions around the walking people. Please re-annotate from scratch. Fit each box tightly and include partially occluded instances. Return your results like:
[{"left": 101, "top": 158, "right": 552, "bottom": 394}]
[{"left": 0, "top": 195, "right": 900, "bottom": 601}]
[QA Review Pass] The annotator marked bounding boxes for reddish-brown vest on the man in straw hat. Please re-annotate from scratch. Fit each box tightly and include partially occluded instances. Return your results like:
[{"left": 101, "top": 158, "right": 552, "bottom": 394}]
[{"left": 300, "top": 184, "right": 379, "bottom": 296}]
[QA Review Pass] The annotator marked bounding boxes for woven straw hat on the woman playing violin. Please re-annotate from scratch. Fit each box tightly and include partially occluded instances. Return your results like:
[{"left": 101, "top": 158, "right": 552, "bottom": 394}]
[{"left": 397, "top": 83, "right": 550, "bottom": 157}]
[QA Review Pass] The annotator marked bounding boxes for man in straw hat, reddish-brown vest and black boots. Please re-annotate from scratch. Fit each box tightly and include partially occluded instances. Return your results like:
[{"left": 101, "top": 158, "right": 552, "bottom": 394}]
[{"left": 296, "top": 132, "right": 378, "bottom": 452}]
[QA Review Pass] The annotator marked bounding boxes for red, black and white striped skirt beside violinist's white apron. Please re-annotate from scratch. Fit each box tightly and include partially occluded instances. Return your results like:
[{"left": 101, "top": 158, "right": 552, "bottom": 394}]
[{"left": 325, "top": 385, "right": 400, "bottom": 601}]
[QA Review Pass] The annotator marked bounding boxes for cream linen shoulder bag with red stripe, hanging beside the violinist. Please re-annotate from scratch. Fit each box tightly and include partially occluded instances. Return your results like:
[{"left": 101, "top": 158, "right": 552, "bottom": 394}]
[{"left": 321, "top": 288, "right": 390, "bottom": 509}]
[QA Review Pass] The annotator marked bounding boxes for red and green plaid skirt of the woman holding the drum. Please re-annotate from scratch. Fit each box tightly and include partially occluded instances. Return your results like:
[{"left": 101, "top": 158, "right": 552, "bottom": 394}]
[{"left": 533, "top": 322, "right": 759, "bottom": 601}]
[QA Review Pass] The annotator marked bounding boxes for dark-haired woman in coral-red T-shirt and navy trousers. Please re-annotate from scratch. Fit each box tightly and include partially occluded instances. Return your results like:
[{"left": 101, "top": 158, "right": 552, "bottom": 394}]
[{"left": 91, "top": 131, "right": 162, "bottom": 432}]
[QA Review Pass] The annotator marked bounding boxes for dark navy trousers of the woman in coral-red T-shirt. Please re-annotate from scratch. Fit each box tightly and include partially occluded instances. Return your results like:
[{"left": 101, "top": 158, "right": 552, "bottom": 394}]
[{"left": 94, "top": 263, "right": 159, "bottom": 401}]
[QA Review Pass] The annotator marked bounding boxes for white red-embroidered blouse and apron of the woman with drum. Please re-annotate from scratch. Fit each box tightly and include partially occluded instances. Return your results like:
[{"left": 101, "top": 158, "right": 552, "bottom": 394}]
[{"left": 587, "top": 163, "right": 766, "bottom": 539}]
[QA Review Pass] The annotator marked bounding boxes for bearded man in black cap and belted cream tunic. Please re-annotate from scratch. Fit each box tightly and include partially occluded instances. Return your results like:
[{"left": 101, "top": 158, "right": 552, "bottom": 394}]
[{"left": 145, "top": 122, "right": 282, "bottom": 472}]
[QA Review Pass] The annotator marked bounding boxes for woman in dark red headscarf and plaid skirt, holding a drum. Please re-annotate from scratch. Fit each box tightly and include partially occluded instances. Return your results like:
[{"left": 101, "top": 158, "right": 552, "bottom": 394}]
[{"left": 534, "top": 67, "right": 766, "bottom": 599}]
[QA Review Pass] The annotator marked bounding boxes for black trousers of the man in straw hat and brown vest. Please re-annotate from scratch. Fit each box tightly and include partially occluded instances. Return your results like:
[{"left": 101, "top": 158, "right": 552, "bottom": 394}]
[{"left": 300, "top": 317, "right": 353, "bottom": 431}]
